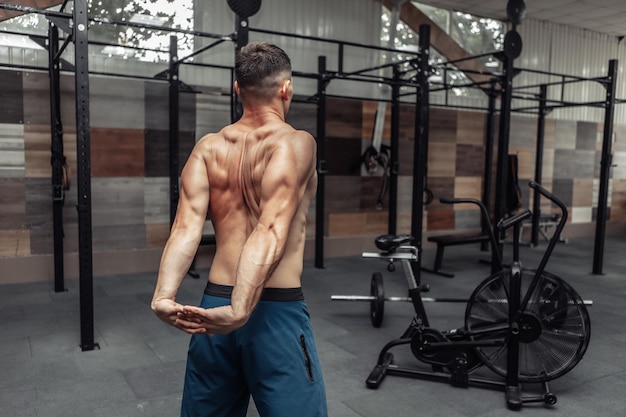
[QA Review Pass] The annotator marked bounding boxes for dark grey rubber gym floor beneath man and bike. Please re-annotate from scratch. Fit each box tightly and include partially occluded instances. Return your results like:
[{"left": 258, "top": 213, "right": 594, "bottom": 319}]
[{"left": 0, "top": 236, "right": 626, "bottom": 417}]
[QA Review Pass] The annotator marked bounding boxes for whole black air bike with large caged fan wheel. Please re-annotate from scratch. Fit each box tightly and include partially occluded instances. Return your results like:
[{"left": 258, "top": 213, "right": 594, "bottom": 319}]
[{"left": 333, "top": 182, "right": 592, "bottom": 409}]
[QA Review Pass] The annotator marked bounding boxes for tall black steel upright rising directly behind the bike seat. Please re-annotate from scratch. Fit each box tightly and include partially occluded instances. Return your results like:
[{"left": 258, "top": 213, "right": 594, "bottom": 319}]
[{"left": 411, "top": 25, "right": 430, "bottom": 280}]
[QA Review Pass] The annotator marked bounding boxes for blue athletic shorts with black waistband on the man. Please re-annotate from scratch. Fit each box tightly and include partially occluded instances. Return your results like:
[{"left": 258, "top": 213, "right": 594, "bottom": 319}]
[{"left": 181, "top": 283, "right": 328, "bottom": 417}]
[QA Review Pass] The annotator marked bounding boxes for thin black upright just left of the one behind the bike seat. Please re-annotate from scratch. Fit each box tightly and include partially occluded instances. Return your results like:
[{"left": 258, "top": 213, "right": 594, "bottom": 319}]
[{"left": 387, "top": 65, "right": 400, "bottom": 235}]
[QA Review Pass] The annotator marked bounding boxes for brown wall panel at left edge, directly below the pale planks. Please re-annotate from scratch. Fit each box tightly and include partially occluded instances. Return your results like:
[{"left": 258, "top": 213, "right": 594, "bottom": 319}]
[{"left": 0, "top": 178, "right": 28, "bottom": 230}]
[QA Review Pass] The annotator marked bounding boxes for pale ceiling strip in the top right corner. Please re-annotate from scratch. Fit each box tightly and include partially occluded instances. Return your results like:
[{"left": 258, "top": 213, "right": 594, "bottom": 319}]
[{"left": 418, "top": 0, "right": 626, "bottom": 37}]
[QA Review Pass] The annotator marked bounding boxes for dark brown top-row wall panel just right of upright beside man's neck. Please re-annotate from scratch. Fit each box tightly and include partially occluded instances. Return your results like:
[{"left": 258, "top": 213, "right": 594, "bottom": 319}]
[{"left": 326, "top": 98, "right": 363, "bottom": 139}]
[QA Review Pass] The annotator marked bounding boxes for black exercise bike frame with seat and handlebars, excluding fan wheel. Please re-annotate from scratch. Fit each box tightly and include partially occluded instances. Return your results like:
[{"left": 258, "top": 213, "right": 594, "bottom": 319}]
[{"left": 364, "top": 181, "right": 584, "bottom": 409}]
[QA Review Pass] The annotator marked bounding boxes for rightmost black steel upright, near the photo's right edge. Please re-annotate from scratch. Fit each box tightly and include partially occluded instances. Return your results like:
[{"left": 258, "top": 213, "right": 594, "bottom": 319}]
[{"left": 593, "top": 59, "right": 618, "bottom": 275}]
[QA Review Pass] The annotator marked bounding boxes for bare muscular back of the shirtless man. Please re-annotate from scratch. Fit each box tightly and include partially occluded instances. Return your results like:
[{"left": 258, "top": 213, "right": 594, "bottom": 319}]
[{"left": 196, "top": 115, "right": 317, "bottom": 288}]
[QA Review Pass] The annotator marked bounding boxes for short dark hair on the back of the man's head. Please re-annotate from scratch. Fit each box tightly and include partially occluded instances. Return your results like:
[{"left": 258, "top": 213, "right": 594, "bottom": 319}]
[{"left": 235, "top": 42, "right": 291, "bottom": 98}]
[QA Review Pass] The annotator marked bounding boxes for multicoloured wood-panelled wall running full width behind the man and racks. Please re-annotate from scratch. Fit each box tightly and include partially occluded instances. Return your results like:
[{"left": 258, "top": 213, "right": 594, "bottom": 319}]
[{"left": 0, "top": 70, "right": 626, "bottom": 281}]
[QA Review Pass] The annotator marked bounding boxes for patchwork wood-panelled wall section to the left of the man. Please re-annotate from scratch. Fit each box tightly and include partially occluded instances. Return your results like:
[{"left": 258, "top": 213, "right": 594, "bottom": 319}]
[{"left": 0, "top": 71, "right": 196, "bottom": 264}]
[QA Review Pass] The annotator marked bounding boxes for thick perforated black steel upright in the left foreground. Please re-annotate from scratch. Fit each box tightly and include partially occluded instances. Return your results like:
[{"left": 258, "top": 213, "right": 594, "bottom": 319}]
[{"left": 73, "top": 0, "right": 98, "bottom": 351}]
